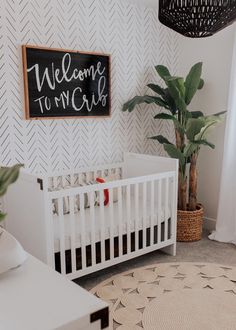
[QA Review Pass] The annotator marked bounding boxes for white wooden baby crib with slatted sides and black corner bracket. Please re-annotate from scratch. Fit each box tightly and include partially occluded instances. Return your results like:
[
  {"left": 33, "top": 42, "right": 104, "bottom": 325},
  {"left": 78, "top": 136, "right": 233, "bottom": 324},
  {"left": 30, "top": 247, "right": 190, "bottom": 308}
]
[{"left": 6, "top": 153, "right": 178, "bottom": 279}]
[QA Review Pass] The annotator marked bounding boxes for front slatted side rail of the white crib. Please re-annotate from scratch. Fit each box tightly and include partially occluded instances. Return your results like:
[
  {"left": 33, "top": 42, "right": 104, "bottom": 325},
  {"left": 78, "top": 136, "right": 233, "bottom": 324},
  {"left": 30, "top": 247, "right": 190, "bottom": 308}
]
[{"left": 48, "top": 171, "right": 177, "bottom": 279}]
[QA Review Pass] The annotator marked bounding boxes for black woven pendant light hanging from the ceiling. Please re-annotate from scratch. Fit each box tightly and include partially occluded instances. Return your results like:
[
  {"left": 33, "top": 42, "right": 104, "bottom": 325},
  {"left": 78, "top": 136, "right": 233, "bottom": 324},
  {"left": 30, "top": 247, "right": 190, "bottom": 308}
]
[{"left": 159, "top": 0, "right": 236, "bottom": 38}]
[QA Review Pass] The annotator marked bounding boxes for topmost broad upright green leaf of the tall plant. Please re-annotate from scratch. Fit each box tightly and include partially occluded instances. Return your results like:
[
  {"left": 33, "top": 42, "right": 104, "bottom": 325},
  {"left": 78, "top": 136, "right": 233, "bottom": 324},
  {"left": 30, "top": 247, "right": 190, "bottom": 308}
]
[{"left": 185, "top": 62, "right": 202, "bottom": 104}]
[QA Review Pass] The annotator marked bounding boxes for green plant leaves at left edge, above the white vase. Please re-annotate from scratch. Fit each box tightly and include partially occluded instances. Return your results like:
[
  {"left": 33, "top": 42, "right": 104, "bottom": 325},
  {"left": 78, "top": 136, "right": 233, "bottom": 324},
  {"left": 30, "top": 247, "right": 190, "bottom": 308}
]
[{"left": 0, "top": 164, "right": 23, "bottom": 222}]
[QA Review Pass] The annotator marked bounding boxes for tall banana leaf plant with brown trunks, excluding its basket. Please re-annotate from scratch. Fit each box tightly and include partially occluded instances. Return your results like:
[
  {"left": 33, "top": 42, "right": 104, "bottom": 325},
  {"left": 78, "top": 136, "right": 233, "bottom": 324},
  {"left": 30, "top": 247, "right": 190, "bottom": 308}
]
[{"left": 122, "top": 62, "right": 224, "bottom": 211}]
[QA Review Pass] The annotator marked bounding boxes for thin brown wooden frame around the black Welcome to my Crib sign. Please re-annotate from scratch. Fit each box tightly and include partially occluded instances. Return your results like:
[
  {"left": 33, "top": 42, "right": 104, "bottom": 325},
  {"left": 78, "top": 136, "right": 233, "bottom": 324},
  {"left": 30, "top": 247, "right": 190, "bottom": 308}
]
[{"left": 21, "top": 45, "right": 111, "bottom": 120}]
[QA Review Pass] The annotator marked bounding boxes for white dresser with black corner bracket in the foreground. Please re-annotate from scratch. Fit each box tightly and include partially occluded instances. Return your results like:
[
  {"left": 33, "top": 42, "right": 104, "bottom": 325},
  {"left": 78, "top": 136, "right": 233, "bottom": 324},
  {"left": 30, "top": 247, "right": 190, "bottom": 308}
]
[{"left": 0, "top": 256, "right": 108, "bottom": 330}]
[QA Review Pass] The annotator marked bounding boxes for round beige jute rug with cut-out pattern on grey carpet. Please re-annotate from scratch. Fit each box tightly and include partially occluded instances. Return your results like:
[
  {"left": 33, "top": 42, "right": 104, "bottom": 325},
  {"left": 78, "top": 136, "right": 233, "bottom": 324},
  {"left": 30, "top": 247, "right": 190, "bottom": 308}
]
[{"left": 91, "top": 263, "right": 236, "bottom": 330}]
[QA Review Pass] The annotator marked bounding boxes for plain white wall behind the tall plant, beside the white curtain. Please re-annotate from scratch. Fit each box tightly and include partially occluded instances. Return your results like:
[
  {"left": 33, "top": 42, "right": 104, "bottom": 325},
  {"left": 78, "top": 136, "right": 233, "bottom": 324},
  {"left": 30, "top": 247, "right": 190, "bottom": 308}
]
[{"left": 179, "top": 25, "right": 235, "bottom": 223}]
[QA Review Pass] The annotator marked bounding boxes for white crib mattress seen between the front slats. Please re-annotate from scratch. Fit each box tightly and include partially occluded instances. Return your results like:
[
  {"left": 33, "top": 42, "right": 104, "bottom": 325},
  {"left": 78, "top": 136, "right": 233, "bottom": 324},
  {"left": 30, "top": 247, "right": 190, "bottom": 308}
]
[{"left": 53, "top": 197, "right": 171, "bottom": 252}]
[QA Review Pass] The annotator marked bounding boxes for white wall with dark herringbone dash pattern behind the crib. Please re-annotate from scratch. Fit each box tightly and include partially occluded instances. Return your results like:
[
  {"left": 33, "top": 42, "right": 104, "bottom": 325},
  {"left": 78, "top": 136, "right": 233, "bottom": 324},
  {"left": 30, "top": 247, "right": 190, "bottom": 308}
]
[{"left": 0, "top": 0, "right": 178, "bottom": 172}]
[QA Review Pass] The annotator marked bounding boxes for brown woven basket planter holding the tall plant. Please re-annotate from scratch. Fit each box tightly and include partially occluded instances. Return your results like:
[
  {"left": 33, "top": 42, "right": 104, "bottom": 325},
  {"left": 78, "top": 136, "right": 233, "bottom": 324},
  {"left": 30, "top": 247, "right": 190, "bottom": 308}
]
[{"left": 177, "top": 204, "right": 203, "bottom": 242}]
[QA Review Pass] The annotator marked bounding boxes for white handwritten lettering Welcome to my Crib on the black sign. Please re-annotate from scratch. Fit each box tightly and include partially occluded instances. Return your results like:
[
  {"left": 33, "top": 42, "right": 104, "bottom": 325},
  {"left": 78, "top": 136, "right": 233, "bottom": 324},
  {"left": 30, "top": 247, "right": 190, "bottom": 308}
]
[{"left": 27, "top": 53, "right": 108, "bottom": 113}]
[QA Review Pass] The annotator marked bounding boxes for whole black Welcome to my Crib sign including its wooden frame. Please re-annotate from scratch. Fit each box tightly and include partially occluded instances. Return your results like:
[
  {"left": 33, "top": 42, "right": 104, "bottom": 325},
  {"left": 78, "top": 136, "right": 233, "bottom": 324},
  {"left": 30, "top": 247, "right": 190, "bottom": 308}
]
[{"left": 22, "top": 45, "right": 111, "bottom": 119}]
